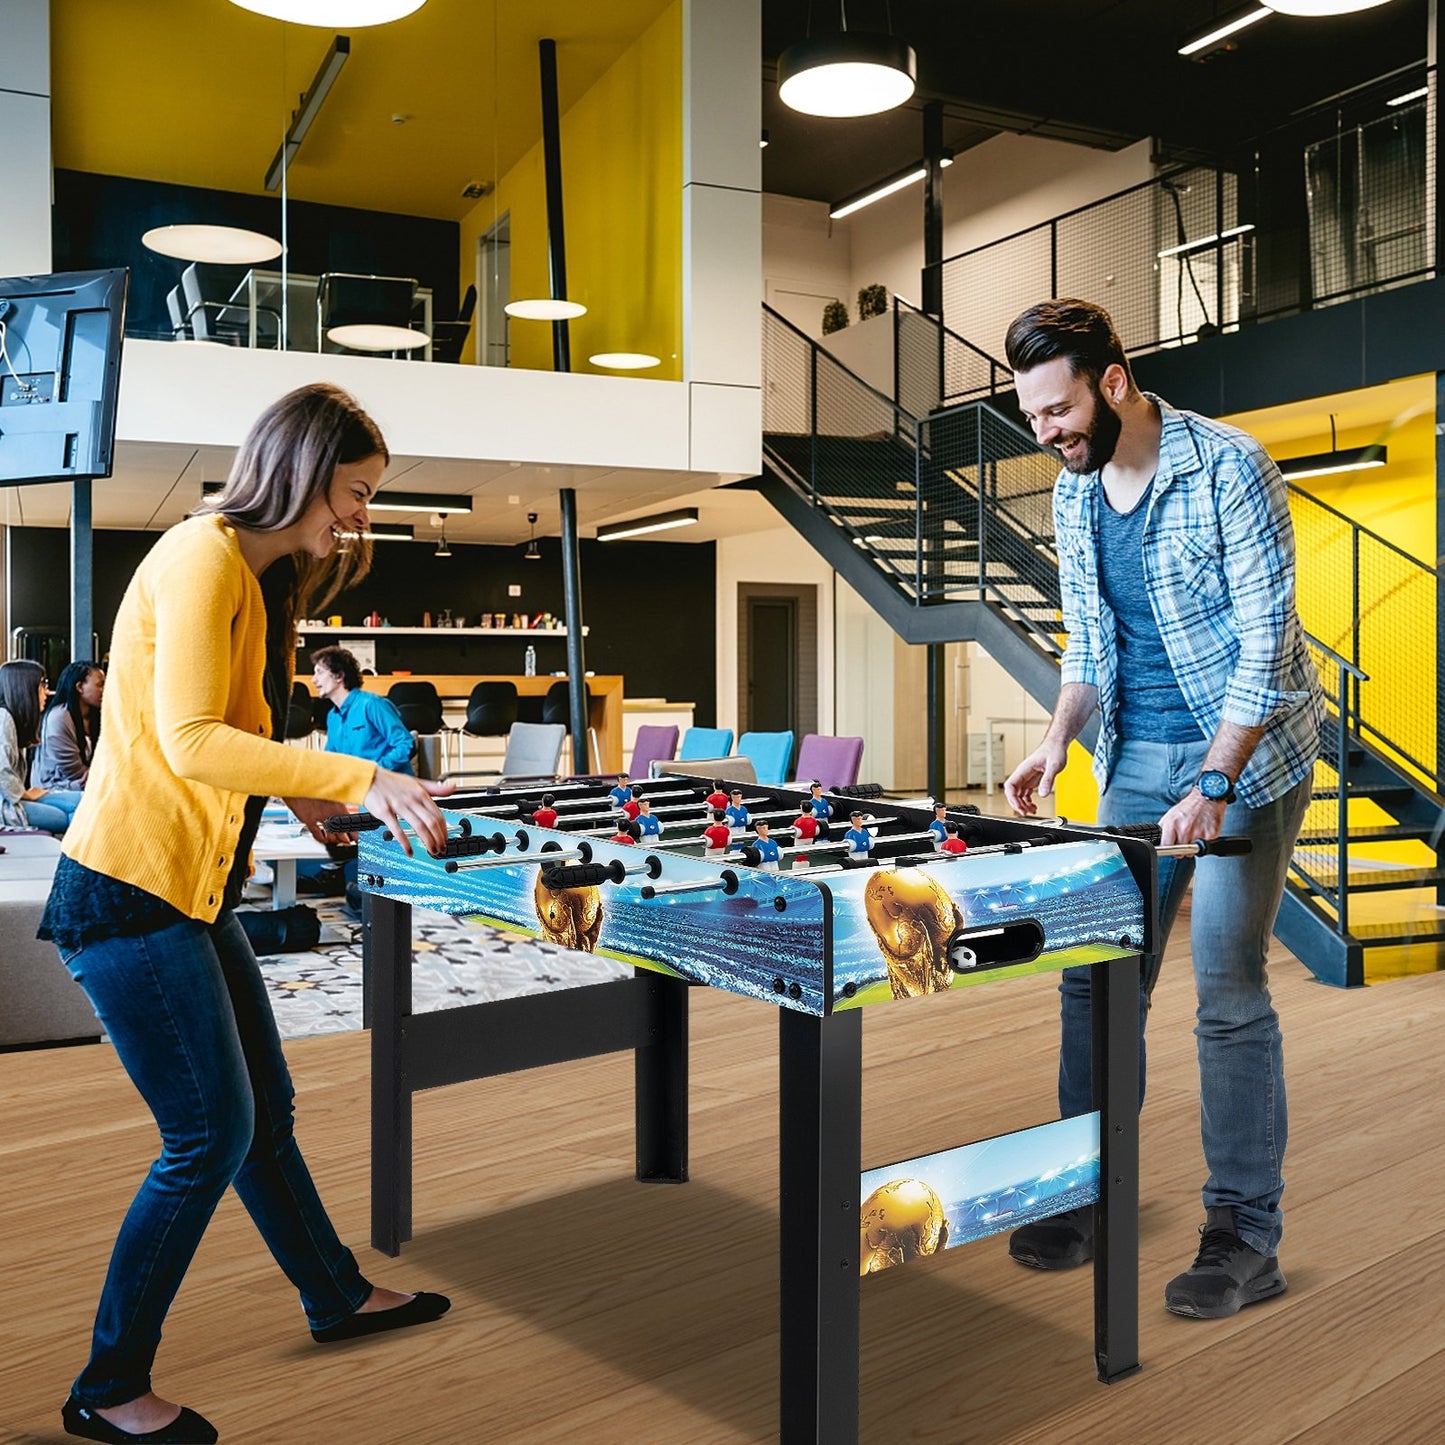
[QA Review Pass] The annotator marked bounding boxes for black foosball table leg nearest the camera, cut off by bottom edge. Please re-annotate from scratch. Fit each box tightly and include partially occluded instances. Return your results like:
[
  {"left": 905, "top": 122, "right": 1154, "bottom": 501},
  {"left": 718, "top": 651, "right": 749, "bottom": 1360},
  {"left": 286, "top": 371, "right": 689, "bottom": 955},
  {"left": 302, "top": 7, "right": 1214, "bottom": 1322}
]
[{"left": 777, "top": 1009, "right": 863, "bottom": 1445}]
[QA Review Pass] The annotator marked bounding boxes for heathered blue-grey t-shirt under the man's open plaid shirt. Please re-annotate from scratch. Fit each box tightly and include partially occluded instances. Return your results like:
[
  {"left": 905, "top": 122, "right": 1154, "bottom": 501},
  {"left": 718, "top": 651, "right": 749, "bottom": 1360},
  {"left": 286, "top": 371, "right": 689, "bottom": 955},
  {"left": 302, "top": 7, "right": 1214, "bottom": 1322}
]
[{"left": 1098, "top": 488, "right": 1204, "bottom": 743}]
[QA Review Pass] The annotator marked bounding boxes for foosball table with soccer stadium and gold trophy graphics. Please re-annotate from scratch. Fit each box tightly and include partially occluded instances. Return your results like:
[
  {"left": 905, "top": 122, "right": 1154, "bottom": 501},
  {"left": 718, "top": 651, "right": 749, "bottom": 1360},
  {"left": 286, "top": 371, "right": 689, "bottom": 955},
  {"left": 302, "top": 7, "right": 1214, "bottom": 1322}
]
[{"left": 341, "top": 776, "right": 1233, "bottom": 1445}]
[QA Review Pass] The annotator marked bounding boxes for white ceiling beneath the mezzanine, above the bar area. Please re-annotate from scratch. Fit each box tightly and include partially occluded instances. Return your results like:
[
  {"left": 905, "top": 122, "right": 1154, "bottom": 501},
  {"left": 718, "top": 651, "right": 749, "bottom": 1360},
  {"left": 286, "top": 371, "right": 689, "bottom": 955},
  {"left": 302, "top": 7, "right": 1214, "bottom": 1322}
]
[{"left": 0, "top": 442, "right": 782, "bottom": 545}]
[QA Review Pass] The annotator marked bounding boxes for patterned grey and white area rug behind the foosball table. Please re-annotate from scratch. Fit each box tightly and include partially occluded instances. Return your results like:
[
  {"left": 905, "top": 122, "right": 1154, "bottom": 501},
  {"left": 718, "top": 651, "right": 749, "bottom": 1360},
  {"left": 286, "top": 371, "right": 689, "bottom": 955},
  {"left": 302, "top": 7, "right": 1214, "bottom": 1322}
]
[{"left": 242, "top": 897, "right": 631, "bottom": 1039}]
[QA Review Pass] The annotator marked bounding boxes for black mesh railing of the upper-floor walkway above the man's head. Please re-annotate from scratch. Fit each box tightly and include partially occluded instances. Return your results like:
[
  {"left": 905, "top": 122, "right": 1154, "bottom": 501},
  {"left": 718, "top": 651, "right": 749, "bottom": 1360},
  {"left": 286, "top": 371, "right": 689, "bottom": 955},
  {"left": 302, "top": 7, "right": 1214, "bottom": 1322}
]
[{"left": 939, "top": 64, "right": 1438, "bottom": 364}]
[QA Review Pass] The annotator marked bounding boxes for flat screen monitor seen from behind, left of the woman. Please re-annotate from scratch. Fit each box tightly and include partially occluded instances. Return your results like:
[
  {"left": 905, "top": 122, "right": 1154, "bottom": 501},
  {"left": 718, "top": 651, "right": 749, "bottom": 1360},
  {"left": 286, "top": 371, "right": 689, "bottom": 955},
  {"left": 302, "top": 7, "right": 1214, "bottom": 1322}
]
[{"left": 0, "top": 267, "right": 129, "bottom": 487}]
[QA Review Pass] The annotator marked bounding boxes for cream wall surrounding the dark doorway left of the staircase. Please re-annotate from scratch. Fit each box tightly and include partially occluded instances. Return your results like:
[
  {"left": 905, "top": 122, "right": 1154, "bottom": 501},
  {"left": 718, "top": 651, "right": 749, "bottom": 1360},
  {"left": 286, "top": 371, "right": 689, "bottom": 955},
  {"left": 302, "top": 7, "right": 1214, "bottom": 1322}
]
[{"left": 717, "top": 526, "right": 837, "bottom": 733}]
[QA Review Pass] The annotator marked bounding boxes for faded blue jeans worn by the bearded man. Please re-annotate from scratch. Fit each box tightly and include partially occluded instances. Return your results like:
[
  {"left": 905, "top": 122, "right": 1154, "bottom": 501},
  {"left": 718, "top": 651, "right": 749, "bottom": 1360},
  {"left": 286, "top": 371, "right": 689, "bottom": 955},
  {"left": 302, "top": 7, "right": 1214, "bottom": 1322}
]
[{"left": 1059, "top": 738, "right": 1311, "bottom": 1254}]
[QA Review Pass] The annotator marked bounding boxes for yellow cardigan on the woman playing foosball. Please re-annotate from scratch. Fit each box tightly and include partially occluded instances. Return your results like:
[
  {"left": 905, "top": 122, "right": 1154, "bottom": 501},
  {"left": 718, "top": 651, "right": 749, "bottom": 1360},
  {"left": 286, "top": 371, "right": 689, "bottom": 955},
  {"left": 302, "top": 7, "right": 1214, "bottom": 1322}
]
[{"left": 64, "top": 516, "right": 376, "bottom": 923}]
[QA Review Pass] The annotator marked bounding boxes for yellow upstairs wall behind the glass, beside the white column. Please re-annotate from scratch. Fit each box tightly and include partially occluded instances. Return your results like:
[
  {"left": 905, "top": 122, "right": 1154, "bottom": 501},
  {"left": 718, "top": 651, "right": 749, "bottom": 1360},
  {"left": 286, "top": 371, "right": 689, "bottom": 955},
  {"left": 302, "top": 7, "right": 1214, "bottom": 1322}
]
[{"left": 461, "top": 0, "right": 682, "bottom": 380}]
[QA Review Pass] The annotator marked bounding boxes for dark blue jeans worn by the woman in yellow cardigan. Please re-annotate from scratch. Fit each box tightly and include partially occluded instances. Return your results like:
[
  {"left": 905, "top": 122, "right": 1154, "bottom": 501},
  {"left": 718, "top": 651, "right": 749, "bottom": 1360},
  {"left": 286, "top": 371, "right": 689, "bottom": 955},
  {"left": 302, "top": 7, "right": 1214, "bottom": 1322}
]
[{"left": 61, "top": 910, "right": 371, "bottom": 1409}]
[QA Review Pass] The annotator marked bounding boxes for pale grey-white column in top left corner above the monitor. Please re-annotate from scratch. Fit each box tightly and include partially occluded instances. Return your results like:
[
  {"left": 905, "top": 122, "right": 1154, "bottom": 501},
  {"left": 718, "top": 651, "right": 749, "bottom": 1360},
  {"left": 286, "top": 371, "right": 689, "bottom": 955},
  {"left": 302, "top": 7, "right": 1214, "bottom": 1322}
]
[{"left": 0, "top": 0, "right": 51, "bottom": 276}]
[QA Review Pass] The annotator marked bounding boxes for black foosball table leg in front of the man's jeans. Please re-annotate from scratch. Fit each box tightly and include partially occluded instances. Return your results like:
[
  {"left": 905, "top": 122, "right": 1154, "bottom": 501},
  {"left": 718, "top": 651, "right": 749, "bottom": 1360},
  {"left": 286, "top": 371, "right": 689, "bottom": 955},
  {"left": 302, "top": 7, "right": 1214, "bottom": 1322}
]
[{"left": 1090, "top": 955, "right": 1139, "bottom": 1384}]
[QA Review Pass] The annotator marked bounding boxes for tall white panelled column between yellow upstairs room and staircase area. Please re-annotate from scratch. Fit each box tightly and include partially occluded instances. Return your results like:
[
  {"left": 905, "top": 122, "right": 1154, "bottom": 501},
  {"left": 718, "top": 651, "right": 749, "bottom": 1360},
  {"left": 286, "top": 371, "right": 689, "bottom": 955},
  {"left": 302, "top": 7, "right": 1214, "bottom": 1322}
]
[{"left": 682, "top": 0, "right": 763, "bottom": 475}]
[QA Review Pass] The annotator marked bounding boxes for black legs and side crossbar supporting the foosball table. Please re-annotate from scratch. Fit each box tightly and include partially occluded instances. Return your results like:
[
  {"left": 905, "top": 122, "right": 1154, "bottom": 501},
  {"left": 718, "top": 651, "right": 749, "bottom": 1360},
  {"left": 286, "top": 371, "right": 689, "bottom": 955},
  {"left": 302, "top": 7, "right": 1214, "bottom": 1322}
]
[{"left": 364, "top": 893, "right": 1139, "bottom": 1445}]
